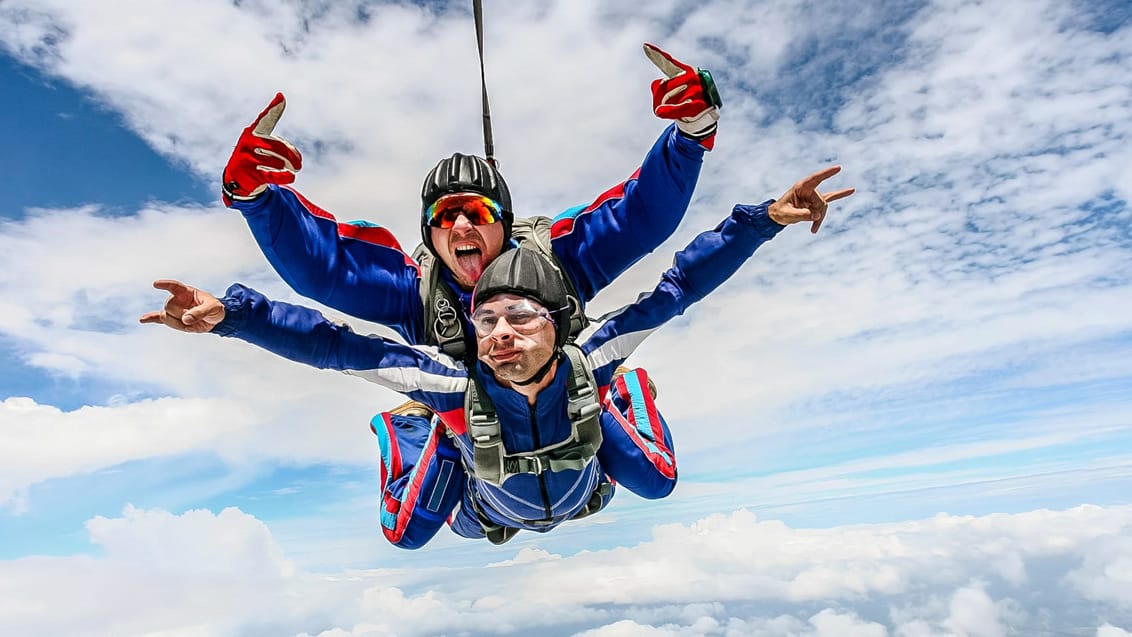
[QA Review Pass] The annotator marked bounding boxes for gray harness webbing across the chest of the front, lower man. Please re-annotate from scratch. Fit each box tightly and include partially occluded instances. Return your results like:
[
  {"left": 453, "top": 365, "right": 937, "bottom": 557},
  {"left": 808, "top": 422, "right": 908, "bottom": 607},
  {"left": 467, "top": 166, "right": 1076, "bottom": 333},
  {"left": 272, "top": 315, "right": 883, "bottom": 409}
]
[{"left": 464, "top": 343, "right": 601, "bottom": 487}]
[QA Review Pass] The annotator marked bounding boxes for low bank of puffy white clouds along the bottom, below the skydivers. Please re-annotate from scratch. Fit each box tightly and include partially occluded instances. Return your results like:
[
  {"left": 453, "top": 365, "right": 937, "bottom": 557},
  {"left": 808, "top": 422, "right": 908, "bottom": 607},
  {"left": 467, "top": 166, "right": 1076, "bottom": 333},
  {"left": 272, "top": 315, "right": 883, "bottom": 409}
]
[{"left": 0, "top": 507, "right": 1132, "bottom": 637}]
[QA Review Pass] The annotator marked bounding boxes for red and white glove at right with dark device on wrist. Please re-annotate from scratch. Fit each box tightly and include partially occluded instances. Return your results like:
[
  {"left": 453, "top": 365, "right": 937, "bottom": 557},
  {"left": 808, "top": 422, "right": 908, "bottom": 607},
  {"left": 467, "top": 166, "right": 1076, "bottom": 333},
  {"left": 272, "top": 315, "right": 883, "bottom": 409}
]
[{"left": 644, "top": 42, "right": 723, "bottom": 149}]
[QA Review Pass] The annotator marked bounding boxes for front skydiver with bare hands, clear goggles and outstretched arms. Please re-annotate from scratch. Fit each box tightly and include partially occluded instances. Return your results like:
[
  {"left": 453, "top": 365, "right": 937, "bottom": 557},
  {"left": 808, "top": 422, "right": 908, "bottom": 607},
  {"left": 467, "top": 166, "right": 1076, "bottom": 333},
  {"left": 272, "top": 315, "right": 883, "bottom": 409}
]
[{"left": 140, "top": 166, "right": 854, "bottom": 549}]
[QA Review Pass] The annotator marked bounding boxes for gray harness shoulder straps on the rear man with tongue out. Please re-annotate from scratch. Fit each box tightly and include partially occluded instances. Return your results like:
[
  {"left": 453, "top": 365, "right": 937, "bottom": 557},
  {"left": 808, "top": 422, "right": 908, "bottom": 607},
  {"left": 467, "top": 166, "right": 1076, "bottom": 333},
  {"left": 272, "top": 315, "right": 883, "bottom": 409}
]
[{"left": 413, "top": 217, "right": 590, "bottom": 362}]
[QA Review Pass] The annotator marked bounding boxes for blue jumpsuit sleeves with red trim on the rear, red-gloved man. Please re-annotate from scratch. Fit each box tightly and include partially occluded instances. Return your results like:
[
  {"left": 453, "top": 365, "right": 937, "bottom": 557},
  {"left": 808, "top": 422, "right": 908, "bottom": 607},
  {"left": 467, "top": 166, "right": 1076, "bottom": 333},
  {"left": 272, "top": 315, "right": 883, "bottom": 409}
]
[{"left": 232, "top": 126, "right": 704, "bottom": 345}]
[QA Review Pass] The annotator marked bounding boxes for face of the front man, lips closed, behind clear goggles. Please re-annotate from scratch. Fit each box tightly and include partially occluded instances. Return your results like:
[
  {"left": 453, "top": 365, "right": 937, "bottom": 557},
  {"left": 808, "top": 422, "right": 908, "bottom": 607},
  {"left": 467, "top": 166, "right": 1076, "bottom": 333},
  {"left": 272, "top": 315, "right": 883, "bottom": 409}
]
[{"left": 472, "top": 294, "right": 555, "bottom": 382}]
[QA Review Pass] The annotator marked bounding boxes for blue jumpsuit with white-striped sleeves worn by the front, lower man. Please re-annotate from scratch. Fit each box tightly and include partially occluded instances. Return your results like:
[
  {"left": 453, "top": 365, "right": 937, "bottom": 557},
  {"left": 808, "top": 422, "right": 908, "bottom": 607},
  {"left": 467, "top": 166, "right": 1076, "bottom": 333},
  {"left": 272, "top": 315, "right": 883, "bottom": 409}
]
[{"left": 214, "top": 201, "right": 782, "bottom": 548}]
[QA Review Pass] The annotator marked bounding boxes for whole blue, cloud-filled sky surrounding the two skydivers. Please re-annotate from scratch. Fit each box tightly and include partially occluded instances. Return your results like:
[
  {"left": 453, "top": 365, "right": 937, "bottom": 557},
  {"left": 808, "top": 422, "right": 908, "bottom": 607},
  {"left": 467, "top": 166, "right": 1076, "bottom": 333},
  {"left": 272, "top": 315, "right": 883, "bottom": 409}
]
[{"left": 0, "top": 0, "right": 1132, "bottom": 637}]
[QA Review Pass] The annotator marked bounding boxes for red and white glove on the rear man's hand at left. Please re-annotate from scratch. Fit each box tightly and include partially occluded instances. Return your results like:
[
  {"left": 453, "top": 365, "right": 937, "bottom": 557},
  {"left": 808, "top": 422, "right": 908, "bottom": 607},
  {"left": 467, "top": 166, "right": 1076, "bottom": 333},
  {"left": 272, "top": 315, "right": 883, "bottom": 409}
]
[{"left": 222, "top": 93, "right": 302, "bottom": 206}]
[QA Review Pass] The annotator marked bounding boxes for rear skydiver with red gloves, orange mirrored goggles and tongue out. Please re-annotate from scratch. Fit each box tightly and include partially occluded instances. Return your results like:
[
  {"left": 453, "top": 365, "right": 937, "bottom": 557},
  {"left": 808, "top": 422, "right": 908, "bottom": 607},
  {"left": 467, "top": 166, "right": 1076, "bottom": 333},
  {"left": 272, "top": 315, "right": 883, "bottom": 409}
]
[{"left": 216, "top": 44, "right": 719, "bottom": 420}]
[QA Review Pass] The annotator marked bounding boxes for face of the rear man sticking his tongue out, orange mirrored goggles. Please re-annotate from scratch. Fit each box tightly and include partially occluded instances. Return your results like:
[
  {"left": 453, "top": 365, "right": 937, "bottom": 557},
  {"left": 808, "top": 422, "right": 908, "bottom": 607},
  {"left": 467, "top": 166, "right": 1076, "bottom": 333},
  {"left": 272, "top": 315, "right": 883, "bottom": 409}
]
[{"left": 429, "top": 193, "right": 504, "bottom": 290}]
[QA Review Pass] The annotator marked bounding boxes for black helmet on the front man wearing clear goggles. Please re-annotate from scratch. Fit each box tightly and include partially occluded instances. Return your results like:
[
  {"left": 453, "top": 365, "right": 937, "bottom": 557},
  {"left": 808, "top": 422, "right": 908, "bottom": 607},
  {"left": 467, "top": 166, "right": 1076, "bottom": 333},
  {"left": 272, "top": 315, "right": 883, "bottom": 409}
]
[{"left": 472, "top": 248, "right": 571, "bottom": 347}]
